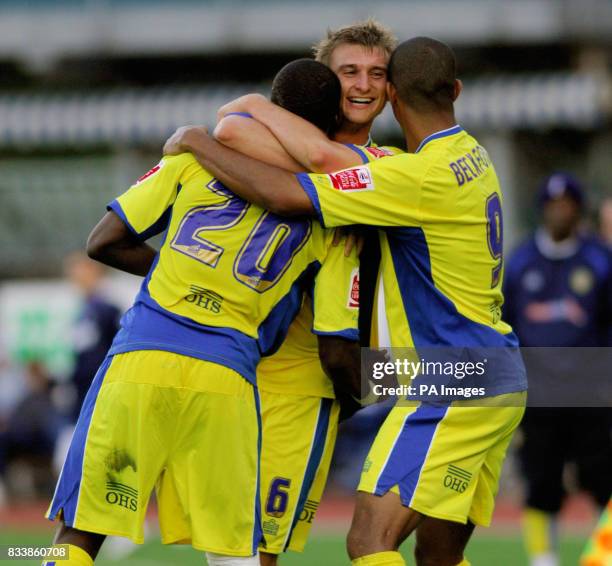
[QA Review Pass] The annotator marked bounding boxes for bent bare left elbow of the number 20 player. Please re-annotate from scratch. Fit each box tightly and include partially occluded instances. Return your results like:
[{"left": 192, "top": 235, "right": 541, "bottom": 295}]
[{"left": 87, "top": 211, "right": 157, "bottom": 277}]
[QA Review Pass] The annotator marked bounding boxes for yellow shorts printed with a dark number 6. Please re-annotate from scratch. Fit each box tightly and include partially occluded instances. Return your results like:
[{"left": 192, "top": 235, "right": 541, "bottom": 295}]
[{"left": 259, "top": 391, "right": 339, "bottom": 554}]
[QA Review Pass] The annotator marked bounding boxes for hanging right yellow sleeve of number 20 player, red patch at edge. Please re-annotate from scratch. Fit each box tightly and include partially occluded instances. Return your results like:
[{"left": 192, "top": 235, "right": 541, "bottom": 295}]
[{"left": 312, "top": 235, "right": 359, "bottom": 341}]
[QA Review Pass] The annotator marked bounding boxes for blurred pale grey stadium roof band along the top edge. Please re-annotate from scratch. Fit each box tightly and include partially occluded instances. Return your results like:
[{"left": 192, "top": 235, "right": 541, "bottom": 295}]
[{"left": 0, "top": 0, "right": 612, "bottom": 67}]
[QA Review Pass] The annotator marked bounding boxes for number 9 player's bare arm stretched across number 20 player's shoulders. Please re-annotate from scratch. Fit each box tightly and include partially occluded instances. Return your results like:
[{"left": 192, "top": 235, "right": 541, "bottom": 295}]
[{"left": 164, "top": 127, "right": 315, "bottom": 216}]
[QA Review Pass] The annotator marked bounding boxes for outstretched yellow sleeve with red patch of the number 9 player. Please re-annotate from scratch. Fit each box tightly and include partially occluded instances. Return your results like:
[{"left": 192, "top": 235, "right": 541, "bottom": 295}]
[{"left": 297, "top": 152, "right": 420, "bottom": 228}]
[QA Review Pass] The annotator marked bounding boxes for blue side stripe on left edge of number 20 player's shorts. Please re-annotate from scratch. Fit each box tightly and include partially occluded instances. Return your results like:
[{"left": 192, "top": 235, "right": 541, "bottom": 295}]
[{"left": 49, "top": 356, "right": 113, "bottom": 527}]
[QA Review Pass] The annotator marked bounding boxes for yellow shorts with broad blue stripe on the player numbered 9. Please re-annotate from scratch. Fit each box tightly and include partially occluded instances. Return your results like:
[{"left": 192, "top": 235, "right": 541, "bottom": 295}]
[{"left": 358, "top": 392, "right": 526, "bottom": 526}]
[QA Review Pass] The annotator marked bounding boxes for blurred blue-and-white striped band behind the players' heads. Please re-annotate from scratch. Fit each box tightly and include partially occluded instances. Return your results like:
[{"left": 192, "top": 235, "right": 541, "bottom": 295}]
[{"left": 0, "top": 73, "right": 611, "bottom": 148}]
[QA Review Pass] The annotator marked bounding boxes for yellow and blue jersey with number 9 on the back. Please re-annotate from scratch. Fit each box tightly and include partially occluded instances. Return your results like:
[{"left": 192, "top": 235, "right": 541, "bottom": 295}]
[{"left": 297, "top": 126, "right": 526, "bottom": 394}]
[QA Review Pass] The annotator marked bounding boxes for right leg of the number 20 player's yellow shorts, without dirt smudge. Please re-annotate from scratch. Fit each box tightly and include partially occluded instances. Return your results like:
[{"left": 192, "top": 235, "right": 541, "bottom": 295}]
[{"left": 158, "top": 359, "right": 261, "bottom": 556}]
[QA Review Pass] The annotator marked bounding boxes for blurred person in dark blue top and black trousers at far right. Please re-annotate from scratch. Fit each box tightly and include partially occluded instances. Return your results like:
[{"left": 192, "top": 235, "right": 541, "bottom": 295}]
[{"left": 505, "top": 173, "right": 612, "bottom": 566}]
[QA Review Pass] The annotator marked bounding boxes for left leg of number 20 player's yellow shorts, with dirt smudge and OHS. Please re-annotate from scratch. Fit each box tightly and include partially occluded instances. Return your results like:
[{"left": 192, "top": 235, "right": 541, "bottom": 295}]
[{"left": 48, "top": 351, "right": 180, "bottom": 542}]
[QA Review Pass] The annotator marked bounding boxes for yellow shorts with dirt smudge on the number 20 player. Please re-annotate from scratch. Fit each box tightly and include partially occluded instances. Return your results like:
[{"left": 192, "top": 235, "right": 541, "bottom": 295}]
[{"left": 47, "top": 350, "right": 261, "bottom": 556}]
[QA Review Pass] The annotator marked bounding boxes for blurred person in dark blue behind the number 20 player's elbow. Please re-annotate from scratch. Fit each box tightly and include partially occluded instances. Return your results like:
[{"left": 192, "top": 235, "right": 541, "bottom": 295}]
[{"left": 64, "top": 252, "right": 121, "bottom": 422}]
